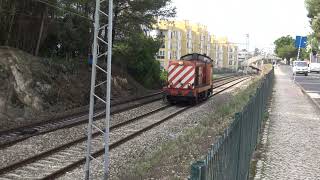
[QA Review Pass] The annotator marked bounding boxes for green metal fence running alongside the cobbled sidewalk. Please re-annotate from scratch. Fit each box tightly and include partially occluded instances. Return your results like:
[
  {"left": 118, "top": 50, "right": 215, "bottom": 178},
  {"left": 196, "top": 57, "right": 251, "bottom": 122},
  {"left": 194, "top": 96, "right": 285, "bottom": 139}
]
[{"left": 190, "top": 70, "right": 274, "bottom": 180}]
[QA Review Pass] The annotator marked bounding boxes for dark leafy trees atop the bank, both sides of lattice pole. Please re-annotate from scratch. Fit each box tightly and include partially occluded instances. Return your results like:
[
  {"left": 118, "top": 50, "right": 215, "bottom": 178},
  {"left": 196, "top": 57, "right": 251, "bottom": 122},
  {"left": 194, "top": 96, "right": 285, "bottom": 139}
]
[{"left": 0, "top": 0, "right": 175, "bottom": 86}]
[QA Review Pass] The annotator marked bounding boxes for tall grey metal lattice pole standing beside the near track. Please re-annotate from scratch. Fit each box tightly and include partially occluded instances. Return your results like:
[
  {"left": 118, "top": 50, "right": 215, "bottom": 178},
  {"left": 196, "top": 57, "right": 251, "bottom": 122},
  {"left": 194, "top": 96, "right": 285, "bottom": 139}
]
[{"left": 85, "top": 0, "right": 113, "bottom": 180}]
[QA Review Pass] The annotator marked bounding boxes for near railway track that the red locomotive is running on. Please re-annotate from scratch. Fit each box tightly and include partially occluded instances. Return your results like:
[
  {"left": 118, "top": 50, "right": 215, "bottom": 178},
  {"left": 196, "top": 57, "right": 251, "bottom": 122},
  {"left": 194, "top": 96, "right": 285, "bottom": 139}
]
[{"left": 0, "top": 77, "right": 249, "bottom": 179}]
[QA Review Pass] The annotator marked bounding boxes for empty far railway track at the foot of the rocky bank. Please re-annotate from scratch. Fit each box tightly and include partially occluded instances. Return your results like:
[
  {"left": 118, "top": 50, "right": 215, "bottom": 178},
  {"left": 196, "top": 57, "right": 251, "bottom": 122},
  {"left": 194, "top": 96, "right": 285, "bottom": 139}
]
[{"left": 0, "top": 92, "right": 162, "bottom": 149}]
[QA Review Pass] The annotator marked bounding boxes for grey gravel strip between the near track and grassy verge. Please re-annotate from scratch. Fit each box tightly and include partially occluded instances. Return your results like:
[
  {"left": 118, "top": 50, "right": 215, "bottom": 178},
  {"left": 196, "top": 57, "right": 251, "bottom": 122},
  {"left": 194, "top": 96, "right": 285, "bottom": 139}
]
[{"left": 59, "top": 79, "right": 251, "bottom": 180}]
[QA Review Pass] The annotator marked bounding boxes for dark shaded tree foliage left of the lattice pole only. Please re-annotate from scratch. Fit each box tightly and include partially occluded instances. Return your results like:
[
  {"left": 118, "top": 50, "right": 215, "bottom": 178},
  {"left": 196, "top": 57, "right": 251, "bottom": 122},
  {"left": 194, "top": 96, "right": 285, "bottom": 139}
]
[{"left": 0, "top": 0, "right": 93, "bottom": 57}]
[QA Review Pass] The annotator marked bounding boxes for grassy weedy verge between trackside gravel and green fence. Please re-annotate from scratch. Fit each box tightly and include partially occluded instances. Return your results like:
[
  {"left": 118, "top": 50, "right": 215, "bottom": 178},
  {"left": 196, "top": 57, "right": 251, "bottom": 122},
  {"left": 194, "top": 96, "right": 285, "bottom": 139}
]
[{"left": 112, "top": 72, "right": 270, "bottom": 179}]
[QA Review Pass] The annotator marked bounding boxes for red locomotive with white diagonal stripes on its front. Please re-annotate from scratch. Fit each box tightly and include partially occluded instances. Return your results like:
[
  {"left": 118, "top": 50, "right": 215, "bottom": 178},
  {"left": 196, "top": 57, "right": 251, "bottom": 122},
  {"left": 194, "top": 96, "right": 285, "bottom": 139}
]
[{"left": 163, "top": 53, "right": 213, "bottom": 103}]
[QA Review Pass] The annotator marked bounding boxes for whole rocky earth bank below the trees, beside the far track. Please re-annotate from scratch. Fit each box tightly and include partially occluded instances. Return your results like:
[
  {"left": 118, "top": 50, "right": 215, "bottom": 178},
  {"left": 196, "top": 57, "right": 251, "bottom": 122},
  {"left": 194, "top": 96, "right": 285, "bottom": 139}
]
[{"left": 0, "top": 47, "right": 149, "bottom": 128}]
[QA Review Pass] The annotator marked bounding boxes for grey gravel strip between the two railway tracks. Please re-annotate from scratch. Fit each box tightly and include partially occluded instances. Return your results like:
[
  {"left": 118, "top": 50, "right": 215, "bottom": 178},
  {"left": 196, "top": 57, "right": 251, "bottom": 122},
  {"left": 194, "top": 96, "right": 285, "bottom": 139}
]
[{"left": 0, "top": 101, "right": 164, "bottom": 168}]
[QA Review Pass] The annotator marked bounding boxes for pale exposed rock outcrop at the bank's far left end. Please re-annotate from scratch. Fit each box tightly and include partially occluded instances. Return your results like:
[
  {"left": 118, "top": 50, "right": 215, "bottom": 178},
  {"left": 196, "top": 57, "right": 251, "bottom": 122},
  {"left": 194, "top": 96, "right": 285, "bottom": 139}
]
[{"left": 0, "top": 47, "right": 47, "bottom": 118}]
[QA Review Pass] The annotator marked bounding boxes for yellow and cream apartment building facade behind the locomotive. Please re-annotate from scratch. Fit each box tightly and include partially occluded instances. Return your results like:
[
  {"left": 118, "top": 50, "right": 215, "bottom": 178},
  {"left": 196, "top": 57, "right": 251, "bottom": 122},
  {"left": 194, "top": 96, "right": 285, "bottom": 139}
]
[{"left": 155, "top": 21, "right": 238, "bottom": 69}]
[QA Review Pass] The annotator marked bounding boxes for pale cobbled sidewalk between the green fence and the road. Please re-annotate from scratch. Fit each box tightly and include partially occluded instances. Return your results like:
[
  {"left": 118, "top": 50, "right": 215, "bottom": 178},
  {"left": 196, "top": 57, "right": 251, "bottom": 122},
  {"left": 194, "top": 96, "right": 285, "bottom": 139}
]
[{"left": 255, "top": 66, "right": 320, "bottom": 180}]
